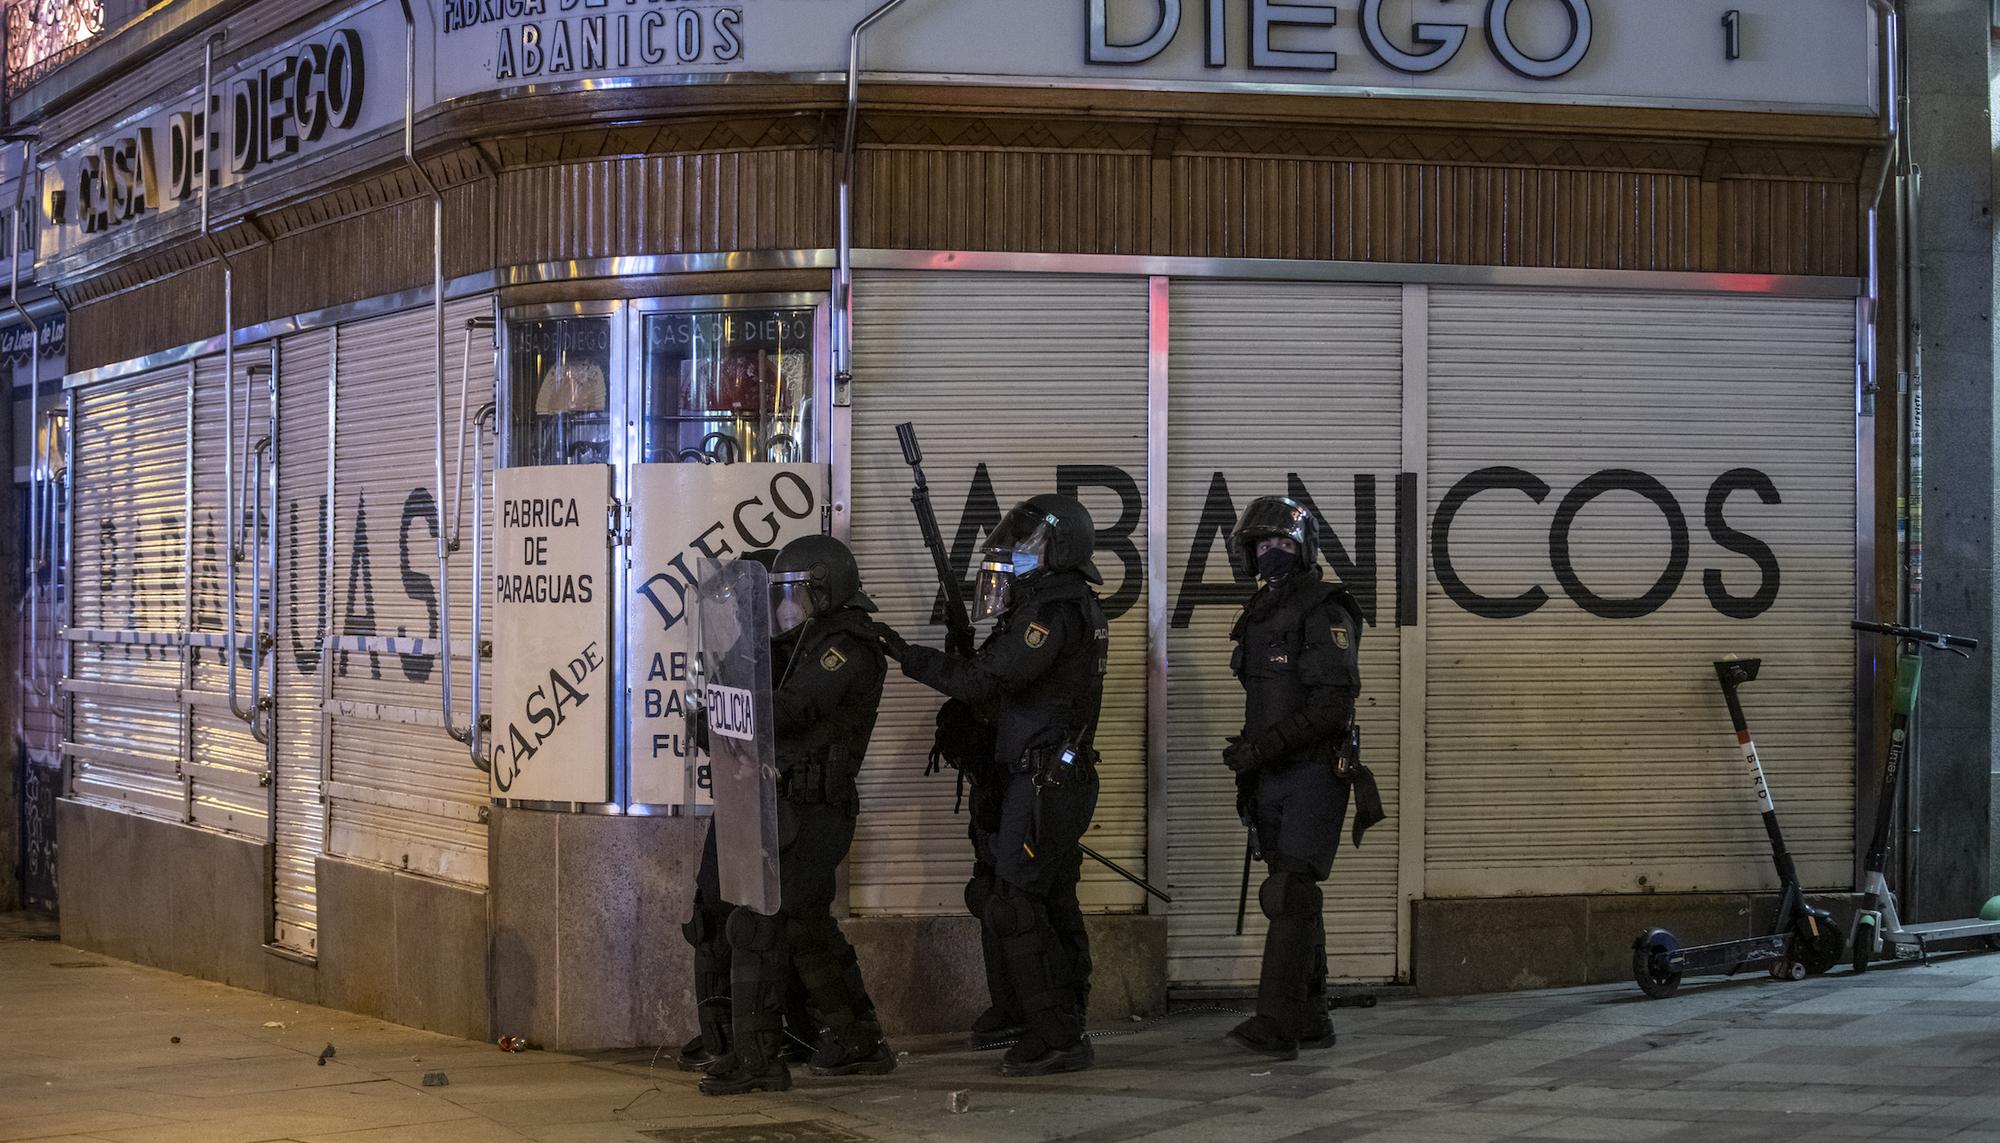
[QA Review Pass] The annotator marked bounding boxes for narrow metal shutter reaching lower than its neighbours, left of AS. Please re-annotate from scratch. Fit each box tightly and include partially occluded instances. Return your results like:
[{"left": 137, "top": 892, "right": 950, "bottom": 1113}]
[{"left": 274, "top": 330, "right": 334, "bottom": 955}]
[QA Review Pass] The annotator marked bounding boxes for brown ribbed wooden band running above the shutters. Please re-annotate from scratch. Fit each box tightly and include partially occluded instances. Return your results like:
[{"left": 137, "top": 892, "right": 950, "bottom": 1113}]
[{"left": 66, "top": 128, "right": 1860, "bottom": 368}]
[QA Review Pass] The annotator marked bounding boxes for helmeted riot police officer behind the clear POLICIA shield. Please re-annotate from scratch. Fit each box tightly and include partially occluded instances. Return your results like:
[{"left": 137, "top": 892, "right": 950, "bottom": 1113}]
[{"left": 690, "top": 536, "right": 896, "bottom": 1095}]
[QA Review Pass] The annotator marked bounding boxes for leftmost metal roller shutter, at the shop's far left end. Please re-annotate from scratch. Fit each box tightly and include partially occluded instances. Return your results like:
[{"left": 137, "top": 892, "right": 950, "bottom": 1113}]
[{"left": 66, "top": 366, "right": 190, "bottom": 821}]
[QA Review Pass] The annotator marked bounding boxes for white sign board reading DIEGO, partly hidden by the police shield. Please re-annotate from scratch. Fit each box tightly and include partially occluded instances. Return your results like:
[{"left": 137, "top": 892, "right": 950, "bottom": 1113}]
[{"left": 626, "top": 464, "right": 828, "bottom": 805}]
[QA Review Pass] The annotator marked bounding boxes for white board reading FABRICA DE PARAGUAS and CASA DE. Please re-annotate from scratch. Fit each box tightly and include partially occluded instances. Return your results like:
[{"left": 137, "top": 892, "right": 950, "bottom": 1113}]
[{"left": 492, "top": 464, "right": 616, "bottom": 801}]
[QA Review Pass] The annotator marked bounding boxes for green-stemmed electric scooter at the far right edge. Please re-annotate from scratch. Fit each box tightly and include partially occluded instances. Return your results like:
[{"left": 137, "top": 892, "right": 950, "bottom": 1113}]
[{"left": 1852, "top": 621, "right": 2000, "bottom": 973}]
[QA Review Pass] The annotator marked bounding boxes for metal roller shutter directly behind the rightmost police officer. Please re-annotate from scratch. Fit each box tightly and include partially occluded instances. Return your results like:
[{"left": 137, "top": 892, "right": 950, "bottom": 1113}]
[{"left": 1164, "top": 282, "right": 1402, "bottom": 987}]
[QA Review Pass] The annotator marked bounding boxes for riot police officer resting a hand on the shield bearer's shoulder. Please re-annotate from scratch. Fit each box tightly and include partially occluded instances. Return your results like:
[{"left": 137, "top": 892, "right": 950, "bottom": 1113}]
[{"left": 876, "top": 496, "right": 1110, "bottom": 1075}]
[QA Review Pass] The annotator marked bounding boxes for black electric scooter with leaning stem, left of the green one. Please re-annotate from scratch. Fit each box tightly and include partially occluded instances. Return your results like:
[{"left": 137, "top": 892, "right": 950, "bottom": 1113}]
[{"left": 1632, "top": 659, "right": 1842, "bottom": 999}]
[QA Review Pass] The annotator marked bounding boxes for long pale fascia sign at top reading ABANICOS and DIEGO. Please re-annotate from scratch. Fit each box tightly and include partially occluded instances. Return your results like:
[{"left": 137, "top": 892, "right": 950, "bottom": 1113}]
[{"left": 436, "top": 0, "right": 1876, "bottom": 114}]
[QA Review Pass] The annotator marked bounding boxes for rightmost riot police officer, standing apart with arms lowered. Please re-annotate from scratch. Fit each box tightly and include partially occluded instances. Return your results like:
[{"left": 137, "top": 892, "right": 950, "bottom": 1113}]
[{"left": 1222, "top": 496, "right": 1362, "bottom": 1059}]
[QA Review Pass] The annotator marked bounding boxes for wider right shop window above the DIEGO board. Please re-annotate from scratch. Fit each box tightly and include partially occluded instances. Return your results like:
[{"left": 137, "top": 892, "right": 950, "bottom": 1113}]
[{"left": 640, "top": 306, "right": 822, "bottom": 464}]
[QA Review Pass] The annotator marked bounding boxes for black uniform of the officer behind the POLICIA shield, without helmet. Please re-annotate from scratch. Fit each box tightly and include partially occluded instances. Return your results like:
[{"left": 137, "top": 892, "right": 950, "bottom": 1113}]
[{"left": 688, "top": 607, "right": 894, "bottom": 1089}]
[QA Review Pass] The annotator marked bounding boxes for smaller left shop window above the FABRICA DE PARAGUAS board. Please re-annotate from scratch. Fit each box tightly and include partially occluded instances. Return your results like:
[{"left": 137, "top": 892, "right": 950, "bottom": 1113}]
[{"left": 508, "top": 316, "right": 614, "bottom": 466}]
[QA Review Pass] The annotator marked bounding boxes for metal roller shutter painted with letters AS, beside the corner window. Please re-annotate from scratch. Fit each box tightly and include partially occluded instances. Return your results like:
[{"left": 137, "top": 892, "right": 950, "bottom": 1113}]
[{"left": 326, "top": 298, "right": 492, "bottom": 885}]
